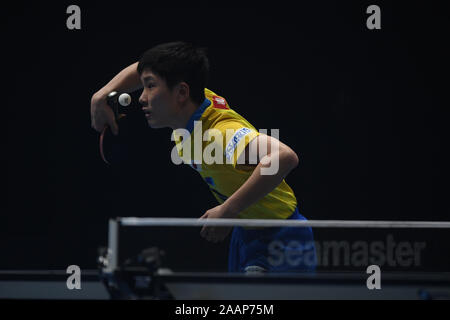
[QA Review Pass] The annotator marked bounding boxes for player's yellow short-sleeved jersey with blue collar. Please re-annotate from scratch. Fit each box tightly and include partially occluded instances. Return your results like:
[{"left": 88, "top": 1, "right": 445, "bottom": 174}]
[{"left": 172, "top": 89, "right": 297, "bottom": 219}]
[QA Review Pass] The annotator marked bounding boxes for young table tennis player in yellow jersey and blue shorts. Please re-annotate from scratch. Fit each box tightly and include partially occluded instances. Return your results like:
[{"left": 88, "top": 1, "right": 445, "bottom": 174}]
[{"left": 91, "top": 42, "right": 316, "bottom": 273}]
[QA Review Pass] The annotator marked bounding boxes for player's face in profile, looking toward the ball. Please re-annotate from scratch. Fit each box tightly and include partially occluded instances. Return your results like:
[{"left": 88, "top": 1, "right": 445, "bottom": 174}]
[{"left": 139, "top": 69, "right": 178, "bottom": 128}]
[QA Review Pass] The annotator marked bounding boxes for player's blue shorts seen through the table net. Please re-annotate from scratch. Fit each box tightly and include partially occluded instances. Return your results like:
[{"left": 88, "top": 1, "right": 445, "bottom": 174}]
[{"left": 228, "top": 208, "right": 317, "bottom": 272}]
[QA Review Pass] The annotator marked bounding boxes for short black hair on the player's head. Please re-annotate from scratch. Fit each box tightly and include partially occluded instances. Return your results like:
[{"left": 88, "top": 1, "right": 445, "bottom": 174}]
[{"left": 137, "top": 41, "right": 209, "bottom": 104}]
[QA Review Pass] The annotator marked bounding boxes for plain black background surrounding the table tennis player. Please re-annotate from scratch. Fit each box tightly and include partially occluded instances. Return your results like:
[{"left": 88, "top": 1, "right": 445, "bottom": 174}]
[{"left": 0, "top": 0, "right": 450, "bottom": 271}]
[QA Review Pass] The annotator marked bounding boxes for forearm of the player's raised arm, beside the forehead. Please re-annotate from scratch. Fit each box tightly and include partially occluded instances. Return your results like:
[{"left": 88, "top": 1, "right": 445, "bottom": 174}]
[{"left": 96, "top": 62, "right": 142, "bottom": 96}]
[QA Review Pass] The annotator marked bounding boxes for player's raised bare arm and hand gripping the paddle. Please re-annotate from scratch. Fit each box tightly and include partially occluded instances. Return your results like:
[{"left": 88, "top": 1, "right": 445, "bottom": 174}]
[{"left": 91, "top": 62, "right": 142, "bottom": 134}]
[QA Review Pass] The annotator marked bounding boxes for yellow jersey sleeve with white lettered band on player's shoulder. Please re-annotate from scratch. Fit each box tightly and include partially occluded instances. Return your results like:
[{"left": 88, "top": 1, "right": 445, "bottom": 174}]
[{"left": 214, "top": 120, "right": 260, "bottom": 167}]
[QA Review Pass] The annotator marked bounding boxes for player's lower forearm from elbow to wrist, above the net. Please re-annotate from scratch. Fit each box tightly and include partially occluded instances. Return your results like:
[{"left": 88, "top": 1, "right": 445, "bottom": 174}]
[{"left": 224, "top": 149, "right": 299, "bottom": 218}]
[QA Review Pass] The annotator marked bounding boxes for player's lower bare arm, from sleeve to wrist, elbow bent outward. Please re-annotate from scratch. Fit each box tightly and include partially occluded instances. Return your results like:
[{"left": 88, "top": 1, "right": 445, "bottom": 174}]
[{"left": 223, "top": 134, "right": 299, "bottom": 218}]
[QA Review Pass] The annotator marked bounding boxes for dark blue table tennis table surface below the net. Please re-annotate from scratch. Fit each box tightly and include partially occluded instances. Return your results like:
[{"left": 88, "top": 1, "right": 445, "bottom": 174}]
[{"left": 0, "top": 268, "right": 450, "bottom": 300}]
